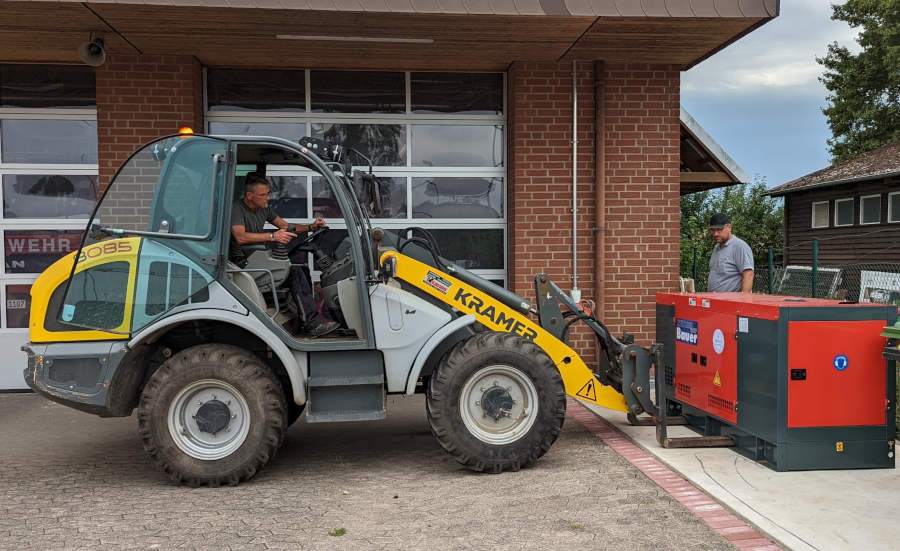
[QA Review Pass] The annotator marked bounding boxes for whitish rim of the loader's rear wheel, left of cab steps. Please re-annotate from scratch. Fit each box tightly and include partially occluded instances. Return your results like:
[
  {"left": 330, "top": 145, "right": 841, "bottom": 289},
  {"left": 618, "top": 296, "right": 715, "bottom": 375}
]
[{"left": 168, "top": 379, "right": 250, "bottom": 461}]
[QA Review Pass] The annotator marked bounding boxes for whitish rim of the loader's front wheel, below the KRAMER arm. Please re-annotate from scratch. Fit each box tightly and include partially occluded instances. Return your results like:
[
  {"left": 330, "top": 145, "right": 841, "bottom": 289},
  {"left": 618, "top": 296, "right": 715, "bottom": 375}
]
[{"left": 459, "top": 365, "right": 538, "bottom": 444}]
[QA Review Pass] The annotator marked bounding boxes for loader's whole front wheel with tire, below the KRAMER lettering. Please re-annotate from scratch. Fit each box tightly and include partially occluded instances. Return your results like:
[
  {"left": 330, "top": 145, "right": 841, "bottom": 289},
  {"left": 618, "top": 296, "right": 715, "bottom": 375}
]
[{"left": 425, "top": 331, "right": 566, "bottom": 473}]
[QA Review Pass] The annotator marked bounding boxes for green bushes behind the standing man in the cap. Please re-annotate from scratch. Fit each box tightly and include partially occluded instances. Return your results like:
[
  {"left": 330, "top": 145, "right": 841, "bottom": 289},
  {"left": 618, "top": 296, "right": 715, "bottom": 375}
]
[{"left": 681, "top": 180, "right": 784, "bottom": 291}]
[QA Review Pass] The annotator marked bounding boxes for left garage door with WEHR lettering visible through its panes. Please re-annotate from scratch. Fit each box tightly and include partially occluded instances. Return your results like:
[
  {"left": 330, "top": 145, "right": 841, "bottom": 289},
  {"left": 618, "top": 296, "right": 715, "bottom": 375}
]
[{"left": 0, "top": 64, "right": 98, "bottom": 336}]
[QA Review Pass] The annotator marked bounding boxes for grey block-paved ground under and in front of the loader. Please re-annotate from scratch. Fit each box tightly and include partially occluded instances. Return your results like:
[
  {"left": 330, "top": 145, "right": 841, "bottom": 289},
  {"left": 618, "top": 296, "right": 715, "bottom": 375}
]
[{"left": 0, "top": 394, "right": 733, "bottom": 550}]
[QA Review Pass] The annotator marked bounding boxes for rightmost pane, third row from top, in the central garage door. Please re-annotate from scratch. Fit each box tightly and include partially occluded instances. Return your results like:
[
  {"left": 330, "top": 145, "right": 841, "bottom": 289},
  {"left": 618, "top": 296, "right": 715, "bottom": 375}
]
[{"left": 412, "top": 176, "right": 503, "bottom": 218}]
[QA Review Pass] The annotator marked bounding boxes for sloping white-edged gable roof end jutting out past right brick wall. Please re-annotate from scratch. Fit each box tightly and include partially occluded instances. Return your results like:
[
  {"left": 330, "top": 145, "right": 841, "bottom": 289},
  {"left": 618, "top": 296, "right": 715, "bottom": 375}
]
[{"left": 681, "top": 107, "right": 750, "bottom": 195}]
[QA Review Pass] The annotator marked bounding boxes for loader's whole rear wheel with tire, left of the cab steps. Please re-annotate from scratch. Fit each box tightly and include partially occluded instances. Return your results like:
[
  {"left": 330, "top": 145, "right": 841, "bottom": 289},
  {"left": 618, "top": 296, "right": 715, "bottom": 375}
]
[{"left": 138, "top": 344, "right": 288, "bottom": 486}]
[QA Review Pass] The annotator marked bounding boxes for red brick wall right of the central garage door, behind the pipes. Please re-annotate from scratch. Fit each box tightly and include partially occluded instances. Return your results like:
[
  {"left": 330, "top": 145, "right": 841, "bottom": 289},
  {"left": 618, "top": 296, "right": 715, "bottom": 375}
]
[{"left": 509, "top": 62, "right": 680, "bottom": 358}]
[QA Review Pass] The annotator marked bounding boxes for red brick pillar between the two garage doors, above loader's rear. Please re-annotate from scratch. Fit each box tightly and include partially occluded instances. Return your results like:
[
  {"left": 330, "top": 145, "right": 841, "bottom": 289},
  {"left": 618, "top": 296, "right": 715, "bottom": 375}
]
[{"left": 96, "top": 55, "right": 203, "bottom": 187}]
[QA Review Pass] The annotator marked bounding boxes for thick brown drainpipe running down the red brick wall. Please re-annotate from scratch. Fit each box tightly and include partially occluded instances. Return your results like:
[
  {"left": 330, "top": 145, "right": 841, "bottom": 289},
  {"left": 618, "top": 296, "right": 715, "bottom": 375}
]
[{"left": 594, "top": 61, "right": 606, "bottom": 319}]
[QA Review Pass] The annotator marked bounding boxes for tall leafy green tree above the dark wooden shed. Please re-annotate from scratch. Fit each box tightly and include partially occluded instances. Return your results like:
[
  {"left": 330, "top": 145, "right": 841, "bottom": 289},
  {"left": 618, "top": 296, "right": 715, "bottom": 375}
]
[{"left": 816, "top": 0, "right": 900, "bottom": 163}]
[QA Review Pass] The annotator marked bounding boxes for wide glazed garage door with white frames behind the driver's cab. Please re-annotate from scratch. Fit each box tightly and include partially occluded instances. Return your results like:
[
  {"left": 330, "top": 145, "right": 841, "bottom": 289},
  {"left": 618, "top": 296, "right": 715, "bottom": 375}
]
[{"left": 206, "top": 69, "right": 506, "bottom": 285}]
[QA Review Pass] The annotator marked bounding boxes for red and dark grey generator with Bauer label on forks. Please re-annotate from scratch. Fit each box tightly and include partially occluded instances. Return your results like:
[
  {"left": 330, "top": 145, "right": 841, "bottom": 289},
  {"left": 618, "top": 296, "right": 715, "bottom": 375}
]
[{"left": 656, "top": 293, "right": 897, "bottom": 471}]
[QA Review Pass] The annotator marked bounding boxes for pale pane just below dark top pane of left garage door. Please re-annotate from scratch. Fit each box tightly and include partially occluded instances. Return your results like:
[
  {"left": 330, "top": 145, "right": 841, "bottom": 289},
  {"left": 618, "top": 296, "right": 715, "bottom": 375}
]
[{"left": 0, "top": 119, "right": 97, "bottom": 164}]
